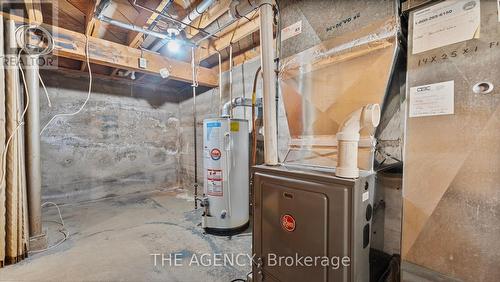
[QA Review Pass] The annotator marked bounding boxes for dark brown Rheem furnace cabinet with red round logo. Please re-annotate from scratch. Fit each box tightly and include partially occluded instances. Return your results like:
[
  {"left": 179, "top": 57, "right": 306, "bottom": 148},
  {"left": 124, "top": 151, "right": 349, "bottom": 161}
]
[{"left": 253, "top": 166, "right": 375, "bottom": 281}]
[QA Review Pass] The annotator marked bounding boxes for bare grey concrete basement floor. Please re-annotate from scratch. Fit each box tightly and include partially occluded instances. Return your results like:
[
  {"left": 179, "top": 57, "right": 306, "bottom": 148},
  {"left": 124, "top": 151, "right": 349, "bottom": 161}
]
[{"left": 0, "top": 191, "right": 251, "bottom": 281}]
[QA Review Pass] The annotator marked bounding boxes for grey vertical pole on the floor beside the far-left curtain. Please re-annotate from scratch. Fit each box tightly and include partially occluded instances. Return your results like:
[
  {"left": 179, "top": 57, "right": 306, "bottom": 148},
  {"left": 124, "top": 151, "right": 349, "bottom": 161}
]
[{"left": 25, "top": 55, "right": 42, "bottom": 237}]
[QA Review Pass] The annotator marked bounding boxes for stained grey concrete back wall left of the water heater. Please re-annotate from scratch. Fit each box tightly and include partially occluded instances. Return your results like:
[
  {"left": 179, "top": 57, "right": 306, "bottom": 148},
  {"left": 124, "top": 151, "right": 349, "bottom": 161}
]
[{"left": 40, "top": 72, "right": 179, "bottom": 202}]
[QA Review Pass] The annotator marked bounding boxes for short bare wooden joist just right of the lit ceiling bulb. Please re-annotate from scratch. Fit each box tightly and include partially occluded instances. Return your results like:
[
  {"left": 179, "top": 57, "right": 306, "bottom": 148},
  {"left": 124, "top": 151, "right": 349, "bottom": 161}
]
[{"left": 200, "top": 12, "right": 260, "bottom": 61}]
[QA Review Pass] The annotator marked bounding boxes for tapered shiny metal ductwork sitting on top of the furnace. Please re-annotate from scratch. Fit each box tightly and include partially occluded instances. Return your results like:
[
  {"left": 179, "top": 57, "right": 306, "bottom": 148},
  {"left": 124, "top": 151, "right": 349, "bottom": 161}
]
[{"left": 280, "top": 9, "right": 400, "bottom": 170}]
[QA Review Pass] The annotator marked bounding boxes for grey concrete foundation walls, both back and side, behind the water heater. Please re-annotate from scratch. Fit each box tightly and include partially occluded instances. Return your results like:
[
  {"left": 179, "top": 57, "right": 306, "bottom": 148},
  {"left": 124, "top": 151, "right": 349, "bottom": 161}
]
[{"left": 40, "top": 58, "right": 289, "bottom": 203}]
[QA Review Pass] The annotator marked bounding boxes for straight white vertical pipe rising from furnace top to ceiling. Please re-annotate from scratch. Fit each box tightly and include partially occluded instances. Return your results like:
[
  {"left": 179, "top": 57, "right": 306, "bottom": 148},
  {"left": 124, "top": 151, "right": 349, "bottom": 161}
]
[{"left": 260, "top": 3, "right": 278, "bottom": 165}]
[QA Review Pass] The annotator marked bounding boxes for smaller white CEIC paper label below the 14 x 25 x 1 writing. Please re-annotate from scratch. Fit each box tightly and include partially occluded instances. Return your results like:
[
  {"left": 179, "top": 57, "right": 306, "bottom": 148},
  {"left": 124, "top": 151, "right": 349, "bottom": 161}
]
[{"left": 409, "top": 80, "right": 455, "bottom": 117}]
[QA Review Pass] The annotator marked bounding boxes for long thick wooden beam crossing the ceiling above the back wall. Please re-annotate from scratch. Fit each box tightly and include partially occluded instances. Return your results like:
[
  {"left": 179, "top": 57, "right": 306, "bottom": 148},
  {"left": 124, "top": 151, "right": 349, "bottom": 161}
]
[{"left": 2, "top": 13, "right": 218, "bottom": 87}]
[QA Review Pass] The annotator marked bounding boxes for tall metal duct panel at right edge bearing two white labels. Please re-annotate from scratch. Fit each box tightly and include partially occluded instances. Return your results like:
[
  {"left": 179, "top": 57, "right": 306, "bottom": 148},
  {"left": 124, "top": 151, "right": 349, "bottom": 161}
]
[{"left": 402, "top": 1, "right": 500, "bottom": 281}]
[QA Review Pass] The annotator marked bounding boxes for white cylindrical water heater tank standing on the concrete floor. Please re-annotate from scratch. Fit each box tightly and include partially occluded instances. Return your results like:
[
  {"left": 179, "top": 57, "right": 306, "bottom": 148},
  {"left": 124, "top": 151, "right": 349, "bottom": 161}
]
[{"left": 202, "top": 118, "right": 249, "bottom": 236}]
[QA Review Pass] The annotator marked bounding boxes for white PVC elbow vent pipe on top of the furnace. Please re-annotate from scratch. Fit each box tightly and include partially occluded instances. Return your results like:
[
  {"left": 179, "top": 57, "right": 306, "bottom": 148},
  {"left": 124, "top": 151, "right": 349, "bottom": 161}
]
[{"left": 335, "top": 104, "right": 380, "bottom": 178}]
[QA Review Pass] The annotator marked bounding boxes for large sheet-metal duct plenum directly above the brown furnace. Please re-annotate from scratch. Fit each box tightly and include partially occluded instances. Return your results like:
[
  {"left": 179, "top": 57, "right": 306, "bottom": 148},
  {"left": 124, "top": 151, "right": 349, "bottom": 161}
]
[{"left": 279, "top": 4, "right": 401, "bottom": 170}]
